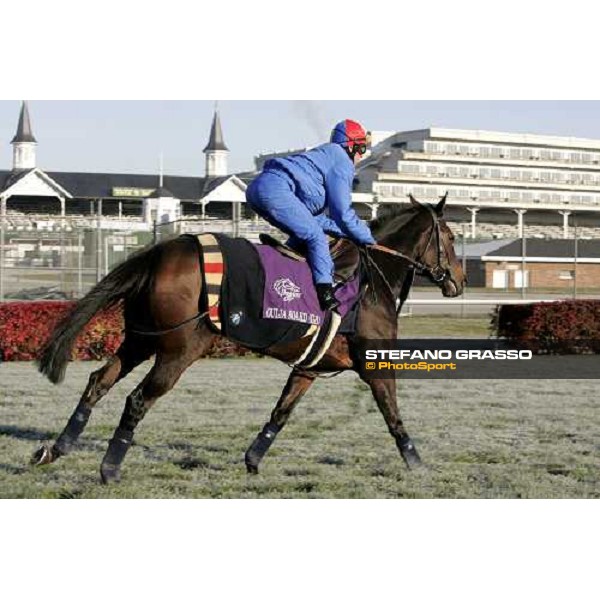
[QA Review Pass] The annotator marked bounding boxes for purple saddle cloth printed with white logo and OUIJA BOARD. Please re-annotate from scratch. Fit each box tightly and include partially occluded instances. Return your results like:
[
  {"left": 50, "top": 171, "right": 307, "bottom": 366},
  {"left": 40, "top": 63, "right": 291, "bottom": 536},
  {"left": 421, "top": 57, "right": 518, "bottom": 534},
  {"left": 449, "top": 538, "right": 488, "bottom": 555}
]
[{"left": 255, "top": 244, "right": 360, "bottom": 325}]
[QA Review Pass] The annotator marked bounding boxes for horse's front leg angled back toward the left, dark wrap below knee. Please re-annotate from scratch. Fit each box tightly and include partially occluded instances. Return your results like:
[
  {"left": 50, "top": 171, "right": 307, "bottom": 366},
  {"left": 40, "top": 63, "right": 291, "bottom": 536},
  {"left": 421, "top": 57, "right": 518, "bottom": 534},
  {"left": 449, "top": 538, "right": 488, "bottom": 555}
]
[{"left": 245, "top": 371, "right": 315, "bottom": 473}]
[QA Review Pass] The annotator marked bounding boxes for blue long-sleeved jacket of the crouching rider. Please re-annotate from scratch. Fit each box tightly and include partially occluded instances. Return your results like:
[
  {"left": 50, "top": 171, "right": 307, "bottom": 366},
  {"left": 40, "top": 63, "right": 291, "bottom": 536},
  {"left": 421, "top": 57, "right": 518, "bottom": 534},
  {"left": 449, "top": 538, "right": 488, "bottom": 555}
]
[{"left": 263, "top": 144, "right": 375, "bottom": 244}]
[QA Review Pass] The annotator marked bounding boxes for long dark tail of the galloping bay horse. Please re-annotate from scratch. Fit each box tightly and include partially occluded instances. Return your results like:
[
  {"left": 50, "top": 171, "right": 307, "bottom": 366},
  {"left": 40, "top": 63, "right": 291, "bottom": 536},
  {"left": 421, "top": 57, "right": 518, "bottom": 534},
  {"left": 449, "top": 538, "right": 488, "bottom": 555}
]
[{"left": 38, "top": 245, "right": 161, "bottom": 383}]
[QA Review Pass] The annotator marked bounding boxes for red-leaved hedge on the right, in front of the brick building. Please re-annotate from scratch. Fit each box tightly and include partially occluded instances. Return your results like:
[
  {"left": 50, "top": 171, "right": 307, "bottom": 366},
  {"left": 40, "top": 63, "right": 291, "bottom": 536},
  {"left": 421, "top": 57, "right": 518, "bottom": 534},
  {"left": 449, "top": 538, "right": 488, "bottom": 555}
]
[{"left": 492, "top": 300, "right": 600, "bottom": 353}]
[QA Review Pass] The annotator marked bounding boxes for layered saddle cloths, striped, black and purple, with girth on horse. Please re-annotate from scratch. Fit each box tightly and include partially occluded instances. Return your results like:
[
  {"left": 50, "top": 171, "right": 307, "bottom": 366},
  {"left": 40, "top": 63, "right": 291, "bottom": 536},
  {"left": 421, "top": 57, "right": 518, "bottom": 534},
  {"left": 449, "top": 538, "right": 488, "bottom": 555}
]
[{"left": 195, "top": 234, "right": 360, "bottom": 368}]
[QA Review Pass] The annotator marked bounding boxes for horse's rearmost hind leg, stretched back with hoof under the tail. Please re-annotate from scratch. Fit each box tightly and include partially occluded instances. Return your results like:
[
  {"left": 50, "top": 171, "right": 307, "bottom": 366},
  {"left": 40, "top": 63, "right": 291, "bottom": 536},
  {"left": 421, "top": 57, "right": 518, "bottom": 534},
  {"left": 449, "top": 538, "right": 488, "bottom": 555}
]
[{"left": 31, "top": 339, "right": 153, "bottom": 465}]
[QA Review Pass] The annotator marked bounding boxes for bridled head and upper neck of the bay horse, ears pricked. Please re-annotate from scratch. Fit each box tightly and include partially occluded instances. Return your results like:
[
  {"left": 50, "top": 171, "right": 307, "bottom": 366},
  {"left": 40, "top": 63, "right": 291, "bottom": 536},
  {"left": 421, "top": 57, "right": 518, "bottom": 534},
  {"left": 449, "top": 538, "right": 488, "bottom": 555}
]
[{"left": 372, "top": 194, "right": 466, "bottom": 297}]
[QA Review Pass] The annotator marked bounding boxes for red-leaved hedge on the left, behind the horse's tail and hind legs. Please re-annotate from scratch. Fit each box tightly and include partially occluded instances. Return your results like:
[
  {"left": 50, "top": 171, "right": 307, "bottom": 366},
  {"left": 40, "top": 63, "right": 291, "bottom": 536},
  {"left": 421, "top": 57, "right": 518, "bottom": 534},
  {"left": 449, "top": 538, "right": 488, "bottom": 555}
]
[{"left": 0, "top": 301, "right": 249, "bottom": 361}]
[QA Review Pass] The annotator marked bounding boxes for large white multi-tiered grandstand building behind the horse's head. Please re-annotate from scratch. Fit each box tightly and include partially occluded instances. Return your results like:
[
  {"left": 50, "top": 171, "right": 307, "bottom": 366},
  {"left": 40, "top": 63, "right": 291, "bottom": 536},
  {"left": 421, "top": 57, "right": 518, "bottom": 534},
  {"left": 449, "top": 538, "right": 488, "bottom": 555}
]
[{"left": 356, "top": 128, "right": 600, "bottom": 238}]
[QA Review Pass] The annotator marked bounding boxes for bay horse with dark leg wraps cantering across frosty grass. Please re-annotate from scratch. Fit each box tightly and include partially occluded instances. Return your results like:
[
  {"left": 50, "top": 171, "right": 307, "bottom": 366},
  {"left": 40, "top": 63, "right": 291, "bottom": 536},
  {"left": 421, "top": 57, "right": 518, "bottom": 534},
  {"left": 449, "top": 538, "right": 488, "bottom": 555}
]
[{"left": 32, "top": 196, "right": 466, "bottom": 483}]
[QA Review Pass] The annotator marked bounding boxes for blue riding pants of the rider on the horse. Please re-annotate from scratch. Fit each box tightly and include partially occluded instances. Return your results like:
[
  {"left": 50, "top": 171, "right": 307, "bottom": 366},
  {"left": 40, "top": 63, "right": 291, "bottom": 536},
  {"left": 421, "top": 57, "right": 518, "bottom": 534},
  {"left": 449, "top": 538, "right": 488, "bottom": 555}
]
[{"left": 246, "top": 171, "right": 337, "bottom": 283}]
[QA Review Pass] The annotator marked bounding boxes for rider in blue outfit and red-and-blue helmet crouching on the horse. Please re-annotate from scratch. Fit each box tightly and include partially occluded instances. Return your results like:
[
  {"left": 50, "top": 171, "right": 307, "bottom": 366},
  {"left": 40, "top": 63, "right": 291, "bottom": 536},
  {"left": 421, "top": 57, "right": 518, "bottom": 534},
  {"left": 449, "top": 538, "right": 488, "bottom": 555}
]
[{"left": 246, "top": 119, "right": 375, "bottom": 310}]
